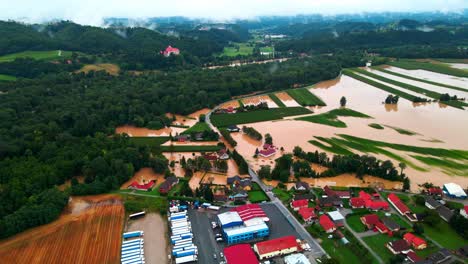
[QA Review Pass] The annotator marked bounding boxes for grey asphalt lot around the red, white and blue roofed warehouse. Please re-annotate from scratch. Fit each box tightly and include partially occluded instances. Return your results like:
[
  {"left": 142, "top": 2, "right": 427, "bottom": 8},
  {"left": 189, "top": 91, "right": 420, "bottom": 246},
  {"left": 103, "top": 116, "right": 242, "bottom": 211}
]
[{"left": 188, "top": 204, "right": 308, "bottom": 264}]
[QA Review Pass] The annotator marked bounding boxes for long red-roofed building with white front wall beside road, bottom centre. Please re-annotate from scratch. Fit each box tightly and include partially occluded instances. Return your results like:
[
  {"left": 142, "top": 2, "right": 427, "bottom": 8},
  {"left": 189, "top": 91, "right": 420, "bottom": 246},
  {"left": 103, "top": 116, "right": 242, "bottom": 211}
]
[{"left": 254, "top": 236, "right": 302, "bottom": 263}]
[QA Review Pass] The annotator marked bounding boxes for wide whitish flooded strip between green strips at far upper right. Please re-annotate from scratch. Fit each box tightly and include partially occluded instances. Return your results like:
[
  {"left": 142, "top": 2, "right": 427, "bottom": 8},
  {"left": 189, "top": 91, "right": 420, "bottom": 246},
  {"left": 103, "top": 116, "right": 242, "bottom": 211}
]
[{"left": 386, "top": 67, "right": 468, "bottom": 88}]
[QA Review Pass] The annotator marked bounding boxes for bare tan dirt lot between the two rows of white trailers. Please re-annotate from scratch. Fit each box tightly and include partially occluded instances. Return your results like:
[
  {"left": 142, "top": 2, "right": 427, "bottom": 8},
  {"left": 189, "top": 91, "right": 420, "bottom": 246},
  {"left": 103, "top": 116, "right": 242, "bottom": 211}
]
[{"left": 126, "top": 213, "right": 169, "bottom": 264}]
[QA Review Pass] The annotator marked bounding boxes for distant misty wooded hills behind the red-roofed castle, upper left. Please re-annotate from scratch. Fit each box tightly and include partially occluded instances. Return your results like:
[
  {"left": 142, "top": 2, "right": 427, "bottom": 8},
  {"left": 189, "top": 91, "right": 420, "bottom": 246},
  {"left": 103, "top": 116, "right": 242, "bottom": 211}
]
[{"left": 0, "top": 21, "right": 248, "bottom": 68}]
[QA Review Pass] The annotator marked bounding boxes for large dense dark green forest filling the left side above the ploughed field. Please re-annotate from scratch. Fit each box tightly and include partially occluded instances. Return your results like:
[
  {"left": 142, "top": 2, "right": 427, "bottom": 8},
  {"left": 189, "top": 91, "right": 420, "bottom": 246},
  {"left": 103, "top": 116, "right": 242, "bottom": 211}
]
[{"left": 0, "top": 56, "right": 348, "bottom": 238}]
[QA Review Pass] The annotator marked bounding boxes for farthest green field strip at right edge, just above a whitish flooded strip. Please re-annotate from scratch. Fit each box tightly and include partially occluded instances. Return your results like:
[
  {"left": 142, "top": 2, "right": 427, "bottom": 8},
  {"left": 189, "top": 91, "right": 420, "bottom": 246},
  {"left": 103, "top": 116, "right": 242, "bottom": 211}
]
[{"left": 388, "top": 60, "right": 468, "bottom": 77}]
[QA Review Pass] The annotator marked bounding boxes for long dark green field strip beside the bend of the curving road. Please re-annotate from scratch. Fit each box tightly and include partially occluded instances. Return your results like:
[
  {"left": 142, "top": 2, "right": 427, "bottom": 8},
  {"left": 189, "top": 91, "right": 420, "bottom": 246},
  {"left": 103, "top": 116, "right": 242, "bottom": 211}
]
[{"left": 211, "top": 107, "right": 311, "bottom": 127}]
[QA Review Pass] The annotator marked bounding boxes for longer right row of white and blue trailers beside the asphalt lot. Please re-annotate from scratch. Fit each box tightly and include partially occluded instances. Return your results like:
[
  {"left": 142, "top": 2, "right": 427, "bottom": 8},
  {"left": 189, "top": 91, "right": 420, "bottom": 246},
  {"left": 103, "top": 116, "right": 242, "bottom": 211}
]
[{"left": 168, "top": 211, "right": 198, "bottom": 264}]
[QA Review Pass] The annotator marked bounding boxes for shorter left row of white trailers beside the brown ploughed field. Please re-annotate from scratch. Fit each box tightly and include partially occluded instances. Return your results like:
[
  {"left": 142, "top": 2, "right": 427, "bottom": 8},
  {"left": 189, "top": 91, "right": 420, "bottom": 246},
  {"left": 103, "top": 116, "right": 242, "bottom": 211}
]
[{"left": 120, "top": 231, "right": 145, "bottom": 264}]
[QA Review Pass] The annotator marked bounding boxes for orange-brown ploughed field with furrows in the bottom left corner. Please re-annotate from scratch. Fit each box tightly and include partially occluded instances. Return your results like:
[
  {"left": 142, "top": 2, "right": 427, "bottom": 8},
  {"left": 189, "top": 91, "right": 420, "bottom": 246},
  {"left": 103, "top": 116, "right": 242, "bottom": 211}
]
[{"left": 0, "top": 195, "right": 124, "bottom": 264}]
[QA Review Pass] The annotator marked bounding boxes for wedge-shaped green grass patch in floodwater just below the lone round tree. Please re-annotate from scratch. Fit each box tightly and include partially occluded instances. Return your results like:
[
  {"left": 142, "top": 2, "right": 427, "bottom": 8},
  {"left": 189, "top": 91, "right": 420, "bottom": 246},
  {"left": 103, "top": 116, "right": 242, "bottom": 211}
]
[{"left": 296, "top": 108, "right": 370, "bottom": 127}]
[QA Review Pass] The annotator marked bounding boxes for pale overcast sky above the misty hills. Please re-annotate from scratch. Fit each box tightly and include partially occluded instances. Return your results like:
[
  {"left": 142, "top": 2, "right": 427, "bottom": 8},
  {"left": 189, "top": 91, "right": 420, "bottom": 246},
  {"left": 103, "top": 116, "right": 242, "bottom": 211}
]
[{"left": 0, "top": 0, "right": 468, "bottom": 25}]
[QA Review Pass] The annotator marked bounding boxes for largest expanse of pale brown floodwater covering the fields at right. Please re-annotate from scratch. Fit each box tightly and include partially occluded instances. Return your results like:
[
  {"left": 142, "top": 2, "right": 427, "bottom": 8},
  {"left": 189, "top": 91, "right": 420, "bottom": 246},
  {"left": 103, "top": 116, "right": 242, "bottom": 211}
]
[{"left": 229, "top": 76, "right": 468, "bottom": 188}]
